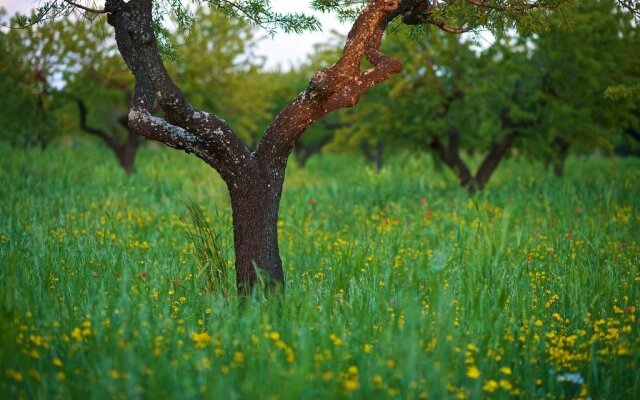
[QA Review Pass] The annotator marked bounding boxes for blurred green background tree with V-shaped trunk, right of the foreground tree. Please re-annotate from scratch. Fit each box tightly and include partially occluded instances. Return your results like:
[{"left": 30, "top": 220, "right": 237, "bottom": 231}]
[{"left": 332, "top": 30, "right": 533, "bottom": 192}]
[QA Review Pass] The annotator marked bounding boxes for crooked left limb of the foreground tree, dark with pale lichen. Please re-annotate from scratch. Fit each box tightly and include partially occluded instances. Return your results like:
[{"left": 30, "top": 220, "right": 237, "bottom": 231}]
[{"left": 107, "top": 0, "right": 252, "bottom": 182}]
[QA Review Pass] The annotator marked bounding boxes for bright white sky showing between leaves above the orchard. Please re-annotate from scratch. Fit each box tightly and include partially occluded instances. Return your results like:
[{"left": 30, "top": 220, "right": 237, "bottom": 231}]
[{"left": 0, "top": 0, "right": 349, "bottom": 69}]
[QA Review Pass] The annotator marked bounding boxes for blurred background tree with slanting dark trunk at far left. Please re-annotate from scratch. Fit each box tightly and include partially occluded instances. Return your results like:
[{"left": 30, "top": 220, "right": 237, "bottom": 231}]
[{"left": 3, "top": 10, "right": 140, "bottom": 167}]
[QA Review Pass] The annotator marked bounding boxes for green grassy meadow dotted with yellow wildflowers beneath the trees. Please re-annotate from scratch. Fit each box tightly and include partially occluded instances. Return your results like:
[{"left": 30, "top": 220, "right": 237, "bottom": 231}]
[{"left": 0, "top": 146, "right": 640, "bottom": 399}]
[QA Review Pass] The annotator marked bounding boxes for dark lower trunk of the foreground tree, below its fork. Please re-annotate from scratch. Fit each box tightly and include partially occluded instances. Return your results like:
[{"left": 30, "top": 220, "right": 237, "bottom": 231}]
[{"left": 229, "top": 169, "right": 284, "bottom": 295}]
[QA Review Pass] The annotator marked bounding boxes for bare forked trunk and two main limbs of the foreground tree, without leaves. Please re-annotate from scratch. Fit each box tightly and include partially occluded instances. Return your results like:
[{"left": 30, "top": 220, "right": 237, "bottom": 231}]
[{"left": 105, "top": 0, "right": 402, "bottom": 294}]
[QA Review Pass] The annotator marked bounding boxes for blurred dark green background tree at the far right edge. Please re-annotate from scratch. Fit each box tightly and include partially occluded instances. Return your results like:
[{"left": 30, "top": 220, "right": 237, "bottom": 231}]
[{"left": 522, "top": 0, "right": 640, "bottom": 176}]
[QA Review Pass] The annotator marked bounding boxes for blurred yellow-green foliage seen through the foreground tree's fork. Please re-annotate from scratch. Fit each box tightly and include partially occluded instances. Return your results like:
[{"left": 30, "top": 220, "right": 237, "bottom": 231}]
[{"left": 169, "top": 8, "right": 273, "bottom": 147}]
